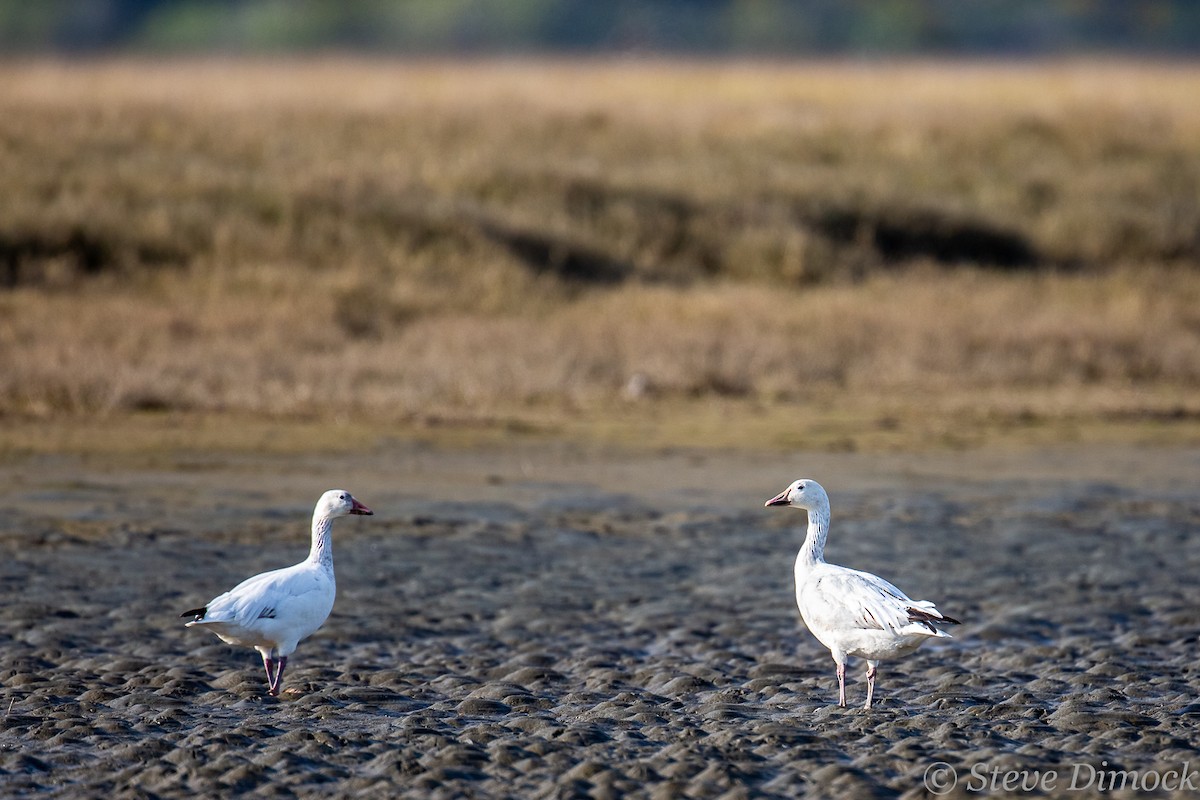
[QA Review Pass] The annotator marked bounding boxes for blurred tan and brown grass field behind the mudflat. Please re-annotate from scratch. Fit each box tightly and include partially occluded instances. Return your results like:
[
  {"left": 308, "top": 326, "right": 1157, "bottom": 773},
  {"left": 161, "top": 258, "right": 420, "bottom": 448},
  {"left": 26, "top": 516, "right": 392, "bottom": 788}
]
[{"left": 0, "top": 59, "right": 1200, "bottom": 450}]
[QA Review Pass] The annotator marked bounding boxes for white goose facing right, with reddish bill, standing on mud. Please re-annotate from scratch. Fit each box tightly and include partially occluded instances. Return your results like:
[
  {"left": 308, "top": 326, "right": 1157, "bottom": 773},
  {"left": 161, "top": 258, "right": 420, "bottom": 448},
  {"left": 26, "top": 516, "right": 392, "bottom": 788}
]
[{"left": 180, "top": 489, "right": 374, "bottom": 696}]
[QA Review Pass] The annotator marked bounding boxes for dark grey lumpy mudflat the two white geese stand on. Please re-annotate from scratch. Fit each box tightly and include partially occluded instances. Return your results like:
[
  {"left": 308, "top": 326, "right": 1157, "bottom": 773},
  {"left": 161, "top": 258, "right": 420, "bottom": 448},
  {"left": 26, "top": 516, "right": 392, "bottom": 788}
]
[{"left": 0, "top": 444, "right": 1200, "bottom": 798}]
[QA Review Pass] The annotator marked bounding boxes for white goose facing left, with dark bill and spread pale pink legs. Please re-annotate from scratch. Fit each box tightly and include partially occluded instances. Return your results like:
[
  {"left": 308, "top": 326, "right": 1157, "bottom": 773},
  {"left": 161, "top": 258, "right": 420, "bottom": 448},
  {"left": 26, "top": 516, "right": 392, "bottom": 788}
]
[{"left": 767, "top": 479, "right": 959, "bottom": 709}]
